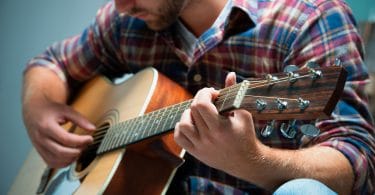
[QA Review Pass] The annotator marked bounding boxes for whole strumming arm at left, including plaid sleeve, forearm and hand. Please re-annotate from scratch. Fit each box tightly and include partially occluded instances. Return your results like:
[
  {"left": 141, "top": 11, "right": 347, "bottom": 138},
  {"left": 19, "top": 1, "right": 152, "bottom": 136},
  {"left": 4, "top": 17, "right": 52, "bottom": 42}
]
[{"left": 22, "top": 3, "right": 126, "bottom": 167}]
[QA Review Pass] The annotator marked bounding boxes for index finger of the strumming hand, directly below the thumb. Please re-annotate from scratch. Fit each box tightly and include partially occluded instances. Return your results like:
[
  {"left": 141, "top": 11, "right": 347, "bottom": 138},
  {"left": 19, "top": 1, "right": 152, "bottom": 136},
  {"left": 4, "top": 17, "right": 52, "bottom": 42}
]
[{"left": 47, "top": 123, "right": 94, "bottom": 148}]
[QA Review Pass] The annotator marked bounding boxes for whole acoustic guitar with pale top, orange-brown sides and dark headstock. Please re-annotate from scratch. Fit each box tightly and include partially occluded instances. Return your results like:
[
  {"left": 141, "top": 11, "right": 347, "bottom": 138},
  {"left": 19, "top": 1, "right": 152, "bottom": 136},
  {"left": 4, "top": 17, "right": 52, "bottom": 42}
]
[{"left": 9, "top": 66, "right": 346, "bottom": 195}]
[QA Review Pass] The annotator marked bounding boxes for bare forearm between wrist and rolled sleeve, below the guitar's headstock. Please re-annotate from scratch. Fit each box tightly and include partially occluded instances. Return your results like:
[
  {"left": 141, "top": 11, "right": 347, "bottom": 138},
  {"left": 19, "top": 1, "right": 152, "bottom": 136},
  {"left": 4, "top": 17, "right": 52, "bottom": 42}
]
[{"left": 239, "top": 143, "right": 354, "bottom": 194}]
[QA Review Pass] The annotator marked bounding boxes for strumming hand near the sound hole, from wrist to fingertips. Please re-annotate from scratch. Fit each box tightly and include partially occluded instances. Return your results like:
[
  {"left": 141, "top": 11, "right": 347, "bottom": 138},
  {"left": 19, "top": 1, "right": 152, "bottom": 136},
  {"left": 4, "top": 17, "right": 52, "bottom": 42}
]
[{"left": 23, "top": 99, "right": 95, "bottom": 168}]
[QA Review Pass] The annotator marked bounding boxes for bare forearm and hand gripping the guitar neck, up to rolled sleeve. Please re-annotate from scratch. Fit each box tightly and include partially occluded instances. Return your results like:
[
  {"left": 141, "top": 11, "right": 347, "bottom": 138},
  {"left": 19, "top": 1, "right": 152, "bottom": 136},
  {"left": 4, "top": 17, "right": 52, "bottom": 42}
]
[{"left": 175, "top": 78, "right": 353, "bottom": 194}]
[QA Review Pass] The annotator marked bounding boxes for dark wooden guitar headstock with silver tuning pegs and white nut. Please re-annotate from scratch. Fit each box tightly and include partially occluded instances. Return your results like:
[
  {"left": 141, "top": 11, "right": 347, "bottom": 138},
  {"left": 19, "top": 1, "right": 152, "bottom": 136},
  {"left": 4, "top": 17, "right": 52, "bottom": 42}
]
[{"left": 215, "top": 66, "right": 347, "bottom": 120}]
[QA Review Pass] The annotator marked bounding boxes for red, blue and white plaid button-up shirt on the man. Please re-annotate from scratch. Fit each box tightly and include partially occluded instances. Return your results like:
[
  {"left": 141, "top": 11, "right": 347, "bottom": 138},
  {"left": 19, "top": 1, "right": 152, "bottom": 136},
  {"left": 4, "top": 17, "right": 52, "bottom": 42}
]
[{"left": 28, "top": 0, "right": 375, "bottom": 194}]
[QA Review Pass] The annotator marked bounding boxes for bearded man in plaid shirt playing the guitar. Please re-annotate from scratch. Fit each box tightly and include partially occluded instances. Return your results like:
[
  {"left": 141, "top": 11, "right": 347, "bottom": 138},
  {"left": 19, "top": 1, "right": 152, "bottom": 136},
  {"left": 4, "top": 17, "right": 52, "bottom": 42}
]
[{"left": 23, "top": 0, "right": 375, "bottom": 194}]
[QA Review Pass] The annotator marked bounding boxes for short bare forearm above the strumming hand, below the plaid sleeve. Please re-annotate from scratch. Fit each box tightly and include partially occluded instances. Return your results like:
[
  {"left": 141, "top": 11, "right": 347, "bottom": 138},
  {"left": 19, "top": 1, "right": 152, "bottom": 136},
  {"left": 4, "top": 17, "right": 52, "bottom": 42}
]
[{"left": 22, "top": 66, "right": 69, "bottom": 106}]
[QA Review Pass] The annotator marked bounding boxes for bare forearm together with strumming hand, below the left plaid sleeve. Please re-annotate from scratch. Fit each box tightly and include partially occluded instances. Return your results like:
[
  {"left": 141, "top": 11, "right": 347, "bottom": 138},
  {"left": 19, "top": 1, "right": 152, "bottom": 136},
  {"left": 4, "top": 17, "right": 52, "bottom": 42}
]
[{"left": 22, "top": 68, "right": 95, "bottom": 168}]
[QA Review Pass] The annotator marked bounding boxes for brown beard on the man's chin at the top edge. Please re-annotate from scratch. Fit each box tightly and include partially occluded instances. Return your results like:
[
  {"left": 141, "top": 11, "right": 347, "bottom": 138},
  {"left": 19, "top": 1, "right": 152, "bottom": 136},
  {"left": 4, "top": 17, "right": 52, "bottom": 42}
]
[{"left": 129, "top": 0, "right": 187, "bottom": 31}]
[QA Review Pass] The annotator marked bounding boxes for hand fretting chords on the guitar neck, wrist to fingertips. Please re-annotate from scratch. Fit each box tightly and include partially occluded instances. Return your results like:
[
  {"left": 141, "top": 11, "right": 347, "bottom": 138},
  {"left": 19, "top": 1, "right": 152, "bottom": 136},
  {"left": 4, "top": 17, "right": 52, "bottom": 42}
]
[{"left": 174, "top": 73, "right": 261, "bottom": 175}]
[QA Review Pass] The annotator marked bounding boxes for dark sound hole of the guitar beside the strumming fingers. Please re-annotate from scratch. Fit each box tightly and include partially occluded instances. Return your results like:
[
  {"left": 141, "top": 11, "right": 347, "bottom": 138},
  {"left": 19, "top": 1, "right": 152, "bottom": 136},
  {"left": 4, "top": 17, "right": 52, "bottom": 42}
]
[{"left": 76, "top": 123, "right": 109, "bottom": 172}]
